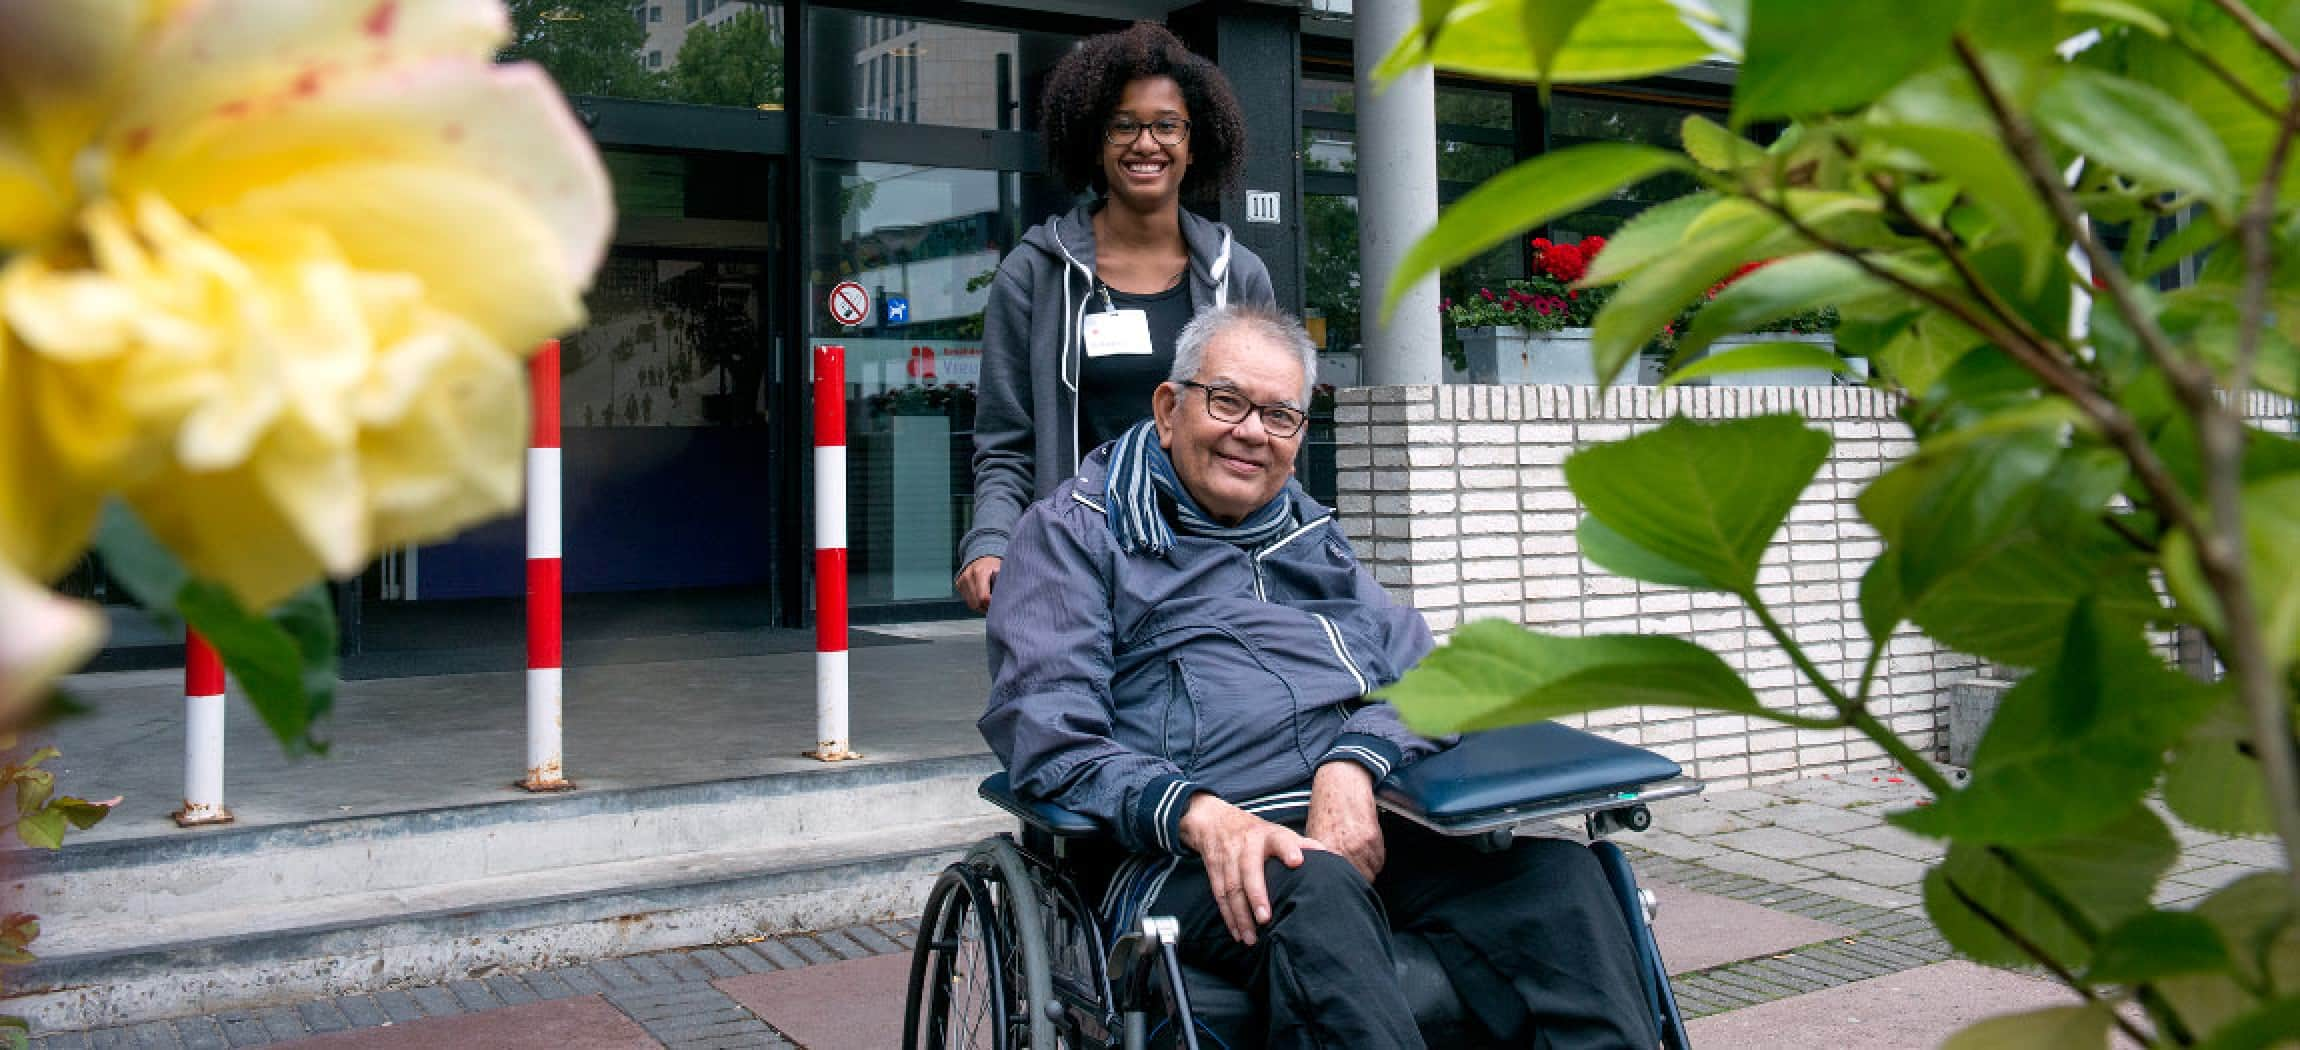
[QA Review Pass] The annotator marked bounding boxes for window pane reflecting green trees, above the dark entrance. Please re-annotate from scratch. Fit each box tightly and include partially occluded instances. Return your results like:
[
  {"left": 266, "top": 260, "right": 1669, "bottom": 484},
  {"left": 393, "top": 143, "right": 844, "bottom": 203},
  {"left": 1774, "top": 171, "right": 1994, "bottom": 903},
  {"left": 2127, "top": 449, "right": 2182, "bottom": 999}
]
[{"left": 497, "top": 0, "right": 782, "bottom": 108}]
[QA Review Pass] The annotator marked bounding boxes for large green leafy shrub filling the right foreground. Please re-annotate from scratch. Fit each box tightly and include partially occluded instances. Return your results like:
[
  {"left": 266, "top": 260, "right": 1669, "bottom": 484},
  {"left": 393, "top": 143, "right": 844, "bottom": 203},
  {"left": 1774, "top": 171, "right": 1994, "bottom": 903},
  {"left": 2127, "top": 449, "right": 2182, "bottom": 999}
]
[{"left": 1382, "top": 0, "right": 2300, "bottom": 1050}]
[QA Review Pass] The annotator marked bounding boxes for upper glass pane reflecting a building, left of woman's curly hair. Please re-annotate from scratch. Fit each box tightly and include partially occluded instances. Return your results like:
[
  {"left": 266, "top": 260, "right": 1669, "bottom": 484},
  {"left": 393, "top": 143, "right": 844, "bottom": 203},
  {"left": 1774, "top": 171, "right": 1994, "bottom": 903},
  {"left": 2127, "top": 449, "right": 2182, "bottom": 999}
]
[{"left": 807, "top": 9, "right": 1076, "bottom": 131}]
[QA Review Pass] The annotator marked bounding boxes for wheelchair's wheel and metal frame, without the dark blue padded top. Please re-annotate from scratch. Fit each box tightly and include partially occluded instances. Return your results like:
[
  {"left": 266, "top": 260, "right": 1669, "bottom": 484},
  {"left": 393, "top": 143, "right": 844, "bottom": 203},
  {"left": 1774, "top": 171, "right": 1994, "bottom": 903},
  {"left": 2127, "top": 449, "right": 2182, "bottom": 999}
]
[{"left": 902, "top": 726, "right": 1702, "bottom": 1050}]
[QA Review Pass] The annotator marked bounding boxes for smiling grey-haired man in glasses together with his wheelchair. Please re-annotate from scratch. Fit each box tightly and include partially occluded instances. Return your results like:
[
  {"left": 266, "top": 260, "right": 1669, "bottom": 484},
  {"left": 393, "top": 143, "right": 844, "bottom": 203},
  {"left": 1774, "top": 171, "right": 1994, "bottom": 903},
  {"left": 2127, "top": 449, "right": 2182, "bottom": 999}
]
[{"left": 906, "top": 306, "right": 1697, "bottom": 1050}]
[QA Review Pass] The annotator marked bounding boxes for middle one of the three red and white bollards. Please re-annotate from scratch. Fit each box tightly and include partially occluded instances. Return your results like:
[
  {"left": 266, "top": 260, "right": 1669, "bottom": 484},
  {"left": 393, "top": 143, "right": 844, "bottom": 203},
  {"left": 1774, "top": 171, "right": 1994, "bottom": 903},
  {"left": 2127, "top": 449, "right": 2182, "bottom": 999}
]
[{"left": 520, "top": 340, "right": 575, "bottom": 790}]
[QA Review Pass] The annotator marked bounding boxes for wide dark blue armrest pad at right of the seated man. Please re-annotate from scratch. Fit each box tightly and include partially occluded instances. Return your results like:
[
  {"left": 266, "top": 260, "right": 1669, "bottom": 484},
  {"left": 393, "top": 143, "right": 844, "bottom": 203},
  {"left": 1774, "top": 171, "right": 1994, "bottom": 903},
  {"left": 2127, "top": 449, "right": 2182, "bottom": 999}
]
[{"left": 1380, "top": 721, "right": 1681, "bottom": 827}]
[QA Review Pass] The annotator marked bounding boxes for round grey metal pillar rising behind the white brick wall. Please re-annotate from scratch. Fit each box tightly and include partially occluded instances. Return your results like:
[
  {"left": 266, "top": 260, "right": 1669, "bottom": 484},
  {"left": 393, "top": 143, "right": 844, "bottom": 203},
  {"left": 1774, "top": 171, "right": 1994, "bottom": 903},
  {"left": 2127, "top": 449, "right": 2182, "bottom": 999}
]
[{"left": 1352, "top": 2, "right": 1444, "bottom": 386}]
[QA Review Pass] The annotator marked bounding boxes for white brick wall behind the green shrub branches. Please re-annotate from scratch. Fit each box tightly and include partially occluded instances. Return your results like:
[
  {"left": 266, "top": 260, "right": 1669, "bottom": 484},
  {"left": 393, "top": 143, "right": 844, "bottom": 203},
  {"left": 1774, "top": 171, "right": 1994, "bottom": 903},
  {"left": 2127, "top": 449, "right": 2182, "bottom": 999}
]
[{"left": 1334, "top": 386, "right": 2293, "bottom": 790}]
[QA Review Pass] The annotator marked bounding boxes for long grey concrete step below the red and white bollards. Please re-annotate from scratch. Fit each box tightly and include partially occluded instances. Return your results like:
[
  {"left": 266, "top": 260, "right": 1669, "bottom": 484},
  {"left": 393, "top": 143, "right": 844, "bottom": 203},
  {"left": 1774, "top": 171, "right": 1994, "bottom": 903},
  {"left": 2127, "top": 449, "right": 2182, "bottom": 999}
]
[{"left": 0, "top": 756, "right": 1012, "bottom": 1029}]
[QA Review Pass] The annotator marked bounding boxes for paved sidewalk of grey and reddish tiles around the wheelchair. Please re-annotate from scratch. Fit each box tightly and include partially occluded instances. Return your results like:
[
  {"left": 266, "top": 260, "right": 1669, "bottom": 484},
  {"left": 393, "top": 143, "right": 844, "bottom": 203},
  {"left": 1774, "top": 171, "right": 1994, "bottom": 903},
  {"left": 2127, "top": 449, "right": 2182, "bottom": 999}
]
[{"left": 35, "top": 772, "right": 2279, "bottom": 1050}]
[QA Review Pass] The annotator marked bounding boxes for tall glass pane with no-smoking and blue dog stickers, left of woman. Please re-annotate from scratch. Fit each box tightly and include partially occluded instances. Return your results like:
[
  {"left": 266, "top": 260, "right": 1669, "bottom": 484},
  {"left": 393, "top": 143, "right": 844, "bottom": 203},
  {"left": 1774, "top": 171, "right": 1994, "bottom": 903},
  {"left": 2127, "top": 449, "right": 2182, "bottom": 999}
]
[{"left": 807, "top": 161, "right": 1067, "bottom": 607}]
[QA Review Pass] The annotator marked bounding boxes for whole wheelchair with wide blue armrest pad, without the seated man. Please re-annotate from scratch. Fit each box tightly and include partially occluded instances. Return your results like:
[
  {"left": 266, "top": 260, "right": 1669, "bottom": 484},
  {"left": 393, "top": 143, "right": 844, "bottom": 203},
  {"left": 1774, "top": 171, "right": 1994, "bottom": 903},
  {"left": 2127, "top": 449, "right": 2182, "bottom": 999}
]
[{"left": 902, "top": 721, "right": 1702, "bottom": 1050}]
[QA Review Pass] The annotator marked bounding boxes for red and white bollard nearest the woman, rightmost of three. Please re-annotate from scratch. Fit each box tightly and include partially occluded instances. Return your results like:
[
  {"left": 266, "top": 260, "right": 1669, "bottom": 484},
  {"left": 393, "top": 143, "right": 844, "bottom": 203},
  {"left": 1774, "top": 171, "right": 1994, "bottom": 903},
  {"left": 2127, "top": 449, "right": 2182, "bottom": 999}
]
[{"left": 807, "top": 347, "right": 860, "bottom": 763}]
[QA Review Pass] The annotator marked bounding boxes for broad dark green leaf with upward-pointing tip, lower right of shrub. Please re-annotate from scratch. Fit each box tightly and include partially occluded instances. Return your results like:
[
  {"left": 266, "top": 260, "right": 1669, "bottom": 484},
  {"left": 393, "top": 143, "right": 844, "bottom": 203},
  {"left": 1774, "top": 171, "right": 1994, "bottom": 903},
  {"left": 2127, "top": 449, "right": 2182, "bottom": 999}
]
[{"left": 1893, "top": 602, "right": 2210, "bottom": 846}]
